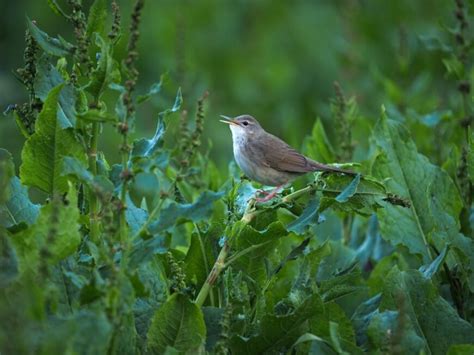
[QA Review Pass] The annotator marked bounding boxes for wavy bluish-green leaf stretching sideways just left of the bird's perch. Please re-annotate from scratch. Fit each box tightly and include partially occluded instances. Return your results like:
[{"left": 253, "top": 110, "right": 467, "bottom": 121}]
[{"left": 149, "top": 191, "right": 224, "bottom": 234}]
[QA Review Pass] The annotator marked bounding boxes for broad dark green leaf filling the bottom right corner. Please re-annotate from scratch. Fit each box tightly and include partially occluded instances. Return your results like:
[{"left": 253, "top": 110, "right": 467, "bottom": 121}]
[{"left": 381, "top": 266, "right": 474, "bottom": 354}]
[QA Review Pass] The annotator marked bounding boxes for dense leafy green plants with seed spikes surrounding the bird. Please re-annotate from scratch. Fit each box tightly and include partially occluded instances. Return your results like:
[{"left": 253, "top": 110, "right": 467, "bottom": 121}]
[{"left": 0, "top": 0, "right": 474, "bottom": 354}]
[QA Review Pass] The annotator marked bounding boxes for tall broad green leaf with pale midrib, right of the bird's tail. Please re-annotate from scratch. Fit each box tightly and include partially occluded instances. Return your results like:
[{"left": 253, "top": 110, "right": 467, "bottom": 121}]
[{"left": 372, "top": 116, "right": 461, "bottom": 261}]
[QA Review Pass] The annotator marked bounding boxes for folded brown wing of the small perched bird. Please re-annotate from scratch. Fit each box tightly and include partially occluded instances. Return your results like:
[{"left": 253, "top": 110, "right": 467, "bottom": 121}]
[{"left": 247, "top": 133, "right": 315, "bottom": 173}]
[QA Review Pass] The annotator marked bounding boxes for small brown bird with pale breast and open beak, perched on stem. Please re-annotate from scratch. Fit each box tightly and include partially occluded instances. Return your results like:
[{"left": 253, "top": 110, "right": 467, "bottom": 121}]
[{"left": 221, "top": 115, "right": 355, "bottom": 202}]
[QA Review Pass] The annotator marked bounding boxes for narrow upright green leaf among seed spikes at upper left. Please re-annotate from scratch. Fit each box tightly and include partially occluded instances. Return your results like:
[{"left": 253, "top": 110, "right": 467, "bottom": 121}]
[{"left": 85, "top": 34, "right": 120, "bottom": 102}]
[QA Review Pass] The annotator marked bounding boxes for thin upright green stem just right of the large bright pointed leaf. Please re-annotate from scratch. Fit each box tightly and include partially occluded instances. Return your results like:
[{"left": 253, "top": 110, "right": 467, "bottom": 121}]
[{"left": 89, "top": 122, "right": 100, "bottom": 242}]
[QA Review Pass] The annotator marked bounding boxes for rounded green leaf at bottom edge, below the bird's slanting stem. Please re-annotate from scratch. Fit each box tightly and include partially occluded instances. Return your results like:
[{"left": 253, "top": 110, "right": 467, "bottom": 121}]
[{"left": 147, "top": 294, "right": 206, "bottom": 354}]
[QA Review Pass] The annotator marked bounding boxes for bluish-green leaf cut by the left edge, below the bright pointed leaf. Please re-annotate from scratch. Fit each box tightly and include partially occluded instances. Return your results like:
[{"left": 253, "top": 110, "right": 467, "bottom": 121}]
[{"left": 0, "top": 176, "right": 40, "bottom": 228}]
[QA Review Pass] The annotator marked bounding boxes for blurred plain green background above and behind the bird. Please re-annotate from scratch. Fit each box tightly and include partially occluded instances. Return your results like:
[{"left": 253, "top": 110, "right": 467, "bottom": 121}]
[{"left": 0, "top": 0, "right": 455, "bottom": 169}]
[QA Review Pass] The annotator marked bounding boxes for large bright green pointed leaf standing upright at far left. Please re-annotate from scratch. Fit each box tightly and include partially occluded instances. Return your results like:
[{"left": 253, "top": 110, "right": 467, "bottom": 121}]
[{"left": 20, "top": 84, "right": 86, "bottom": 194}]
